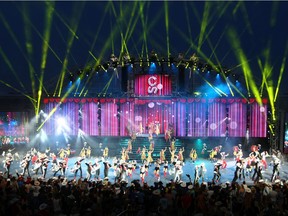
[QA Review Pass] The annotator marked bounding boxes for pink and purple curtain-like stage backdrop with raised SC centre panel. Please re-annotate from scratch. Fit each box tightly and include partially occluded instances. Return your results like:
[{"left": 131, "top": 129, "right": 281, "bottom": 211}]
[{"left": 43, "top": 74, "right": 267, "bottom": 138}]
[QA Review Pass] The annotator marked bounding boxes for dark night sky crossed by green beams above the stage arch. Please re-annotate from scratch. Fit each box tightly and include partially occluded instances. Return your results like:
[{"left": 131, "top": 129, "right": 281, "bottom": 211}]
[{"left": 0, "top": 1, "right": 288, "bottom": 98}]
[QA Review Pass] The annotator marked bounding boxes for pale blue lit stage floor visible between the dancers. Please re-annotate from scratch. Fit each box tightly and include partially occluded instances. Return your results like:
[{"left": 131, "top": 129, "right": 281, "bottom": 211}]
[{"left": 0, "top": 156, "right": 288, "bottom": 185}]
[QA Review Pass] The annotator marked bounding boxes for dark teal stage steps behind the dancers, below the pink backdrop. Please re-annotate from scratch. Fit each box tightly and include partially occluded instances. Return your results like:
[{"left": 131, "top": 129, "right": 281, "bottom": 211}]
[{"left": 119, "top": 136, "right": 183, "bottom": 162}]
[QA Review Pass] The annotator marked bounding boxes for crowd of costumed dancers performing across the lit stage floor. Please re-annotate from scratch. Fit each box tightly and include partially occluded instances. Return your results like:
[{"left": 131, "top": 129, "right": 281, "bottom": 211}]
[{"left": 2, "top": 139, "right": 283, "bottom": 186}]
